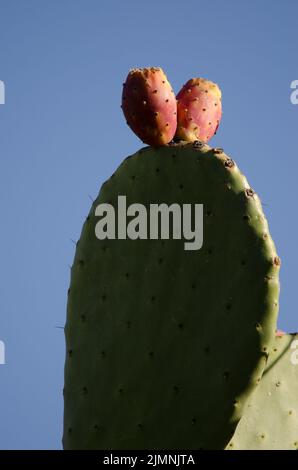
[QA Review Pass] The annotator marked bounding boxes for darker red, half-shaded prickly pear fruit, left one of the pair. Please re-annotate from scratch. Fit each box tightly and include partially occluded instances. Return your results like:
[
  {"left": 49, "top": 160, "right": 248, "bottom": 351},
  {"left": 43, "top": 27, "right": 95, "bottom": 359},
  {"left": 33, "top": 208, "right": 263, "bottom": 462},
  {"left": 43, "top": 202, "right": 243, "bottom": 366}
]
[{"left": 121, "top": 67, "right": 177, "bottom": 147}]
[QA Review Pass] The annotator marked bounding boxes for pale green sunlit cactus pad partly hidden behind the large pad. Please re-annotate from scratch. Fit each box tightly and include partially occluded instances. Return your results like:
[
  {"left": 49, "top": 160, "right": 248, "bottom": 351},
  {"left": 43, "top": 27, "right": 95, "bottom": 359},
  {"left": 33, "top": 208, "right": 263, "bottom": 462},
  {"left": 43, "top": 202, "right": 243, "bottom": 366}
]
[{"left": 227, "top": 334, "right": 298, "bottom": 450}]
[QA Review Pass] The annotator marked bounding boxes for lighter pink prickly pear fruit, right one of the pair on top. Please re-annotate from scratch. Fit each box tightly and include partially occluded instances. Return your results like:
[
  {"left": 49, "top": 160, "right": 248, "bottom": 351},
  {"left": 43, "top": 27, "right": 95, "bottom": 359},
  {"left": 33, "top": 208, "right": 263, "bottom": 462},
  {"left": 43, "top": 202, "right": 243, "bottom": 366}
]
[{"left": 176, "top": 78, "right": 222, "bottom": 142}]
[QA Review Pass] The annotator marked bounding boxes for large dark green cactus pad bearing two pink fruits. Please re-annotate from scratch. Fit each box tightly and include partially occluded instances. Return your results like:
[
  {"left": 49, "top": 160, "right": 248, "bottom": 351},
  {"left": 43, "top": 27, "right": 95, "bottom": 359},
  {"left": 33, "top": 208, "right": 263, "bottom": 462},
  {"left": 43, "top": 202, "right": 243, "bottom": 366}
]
[{"left": 63, "top": 143, "right": 279, "bottom": 449}]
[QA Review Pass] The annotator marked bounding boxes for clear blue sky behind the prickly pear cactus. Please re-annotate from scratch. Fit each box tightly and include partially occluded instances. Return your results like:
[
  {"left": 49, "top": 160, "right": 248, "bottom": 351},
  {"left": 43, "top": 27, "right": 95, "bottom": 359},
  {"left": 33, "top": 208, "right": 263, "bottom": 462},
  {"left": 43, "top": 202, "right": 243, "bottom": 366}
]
[{"left": 0, "top": 0, "right": 298, "bottom": 449}]
